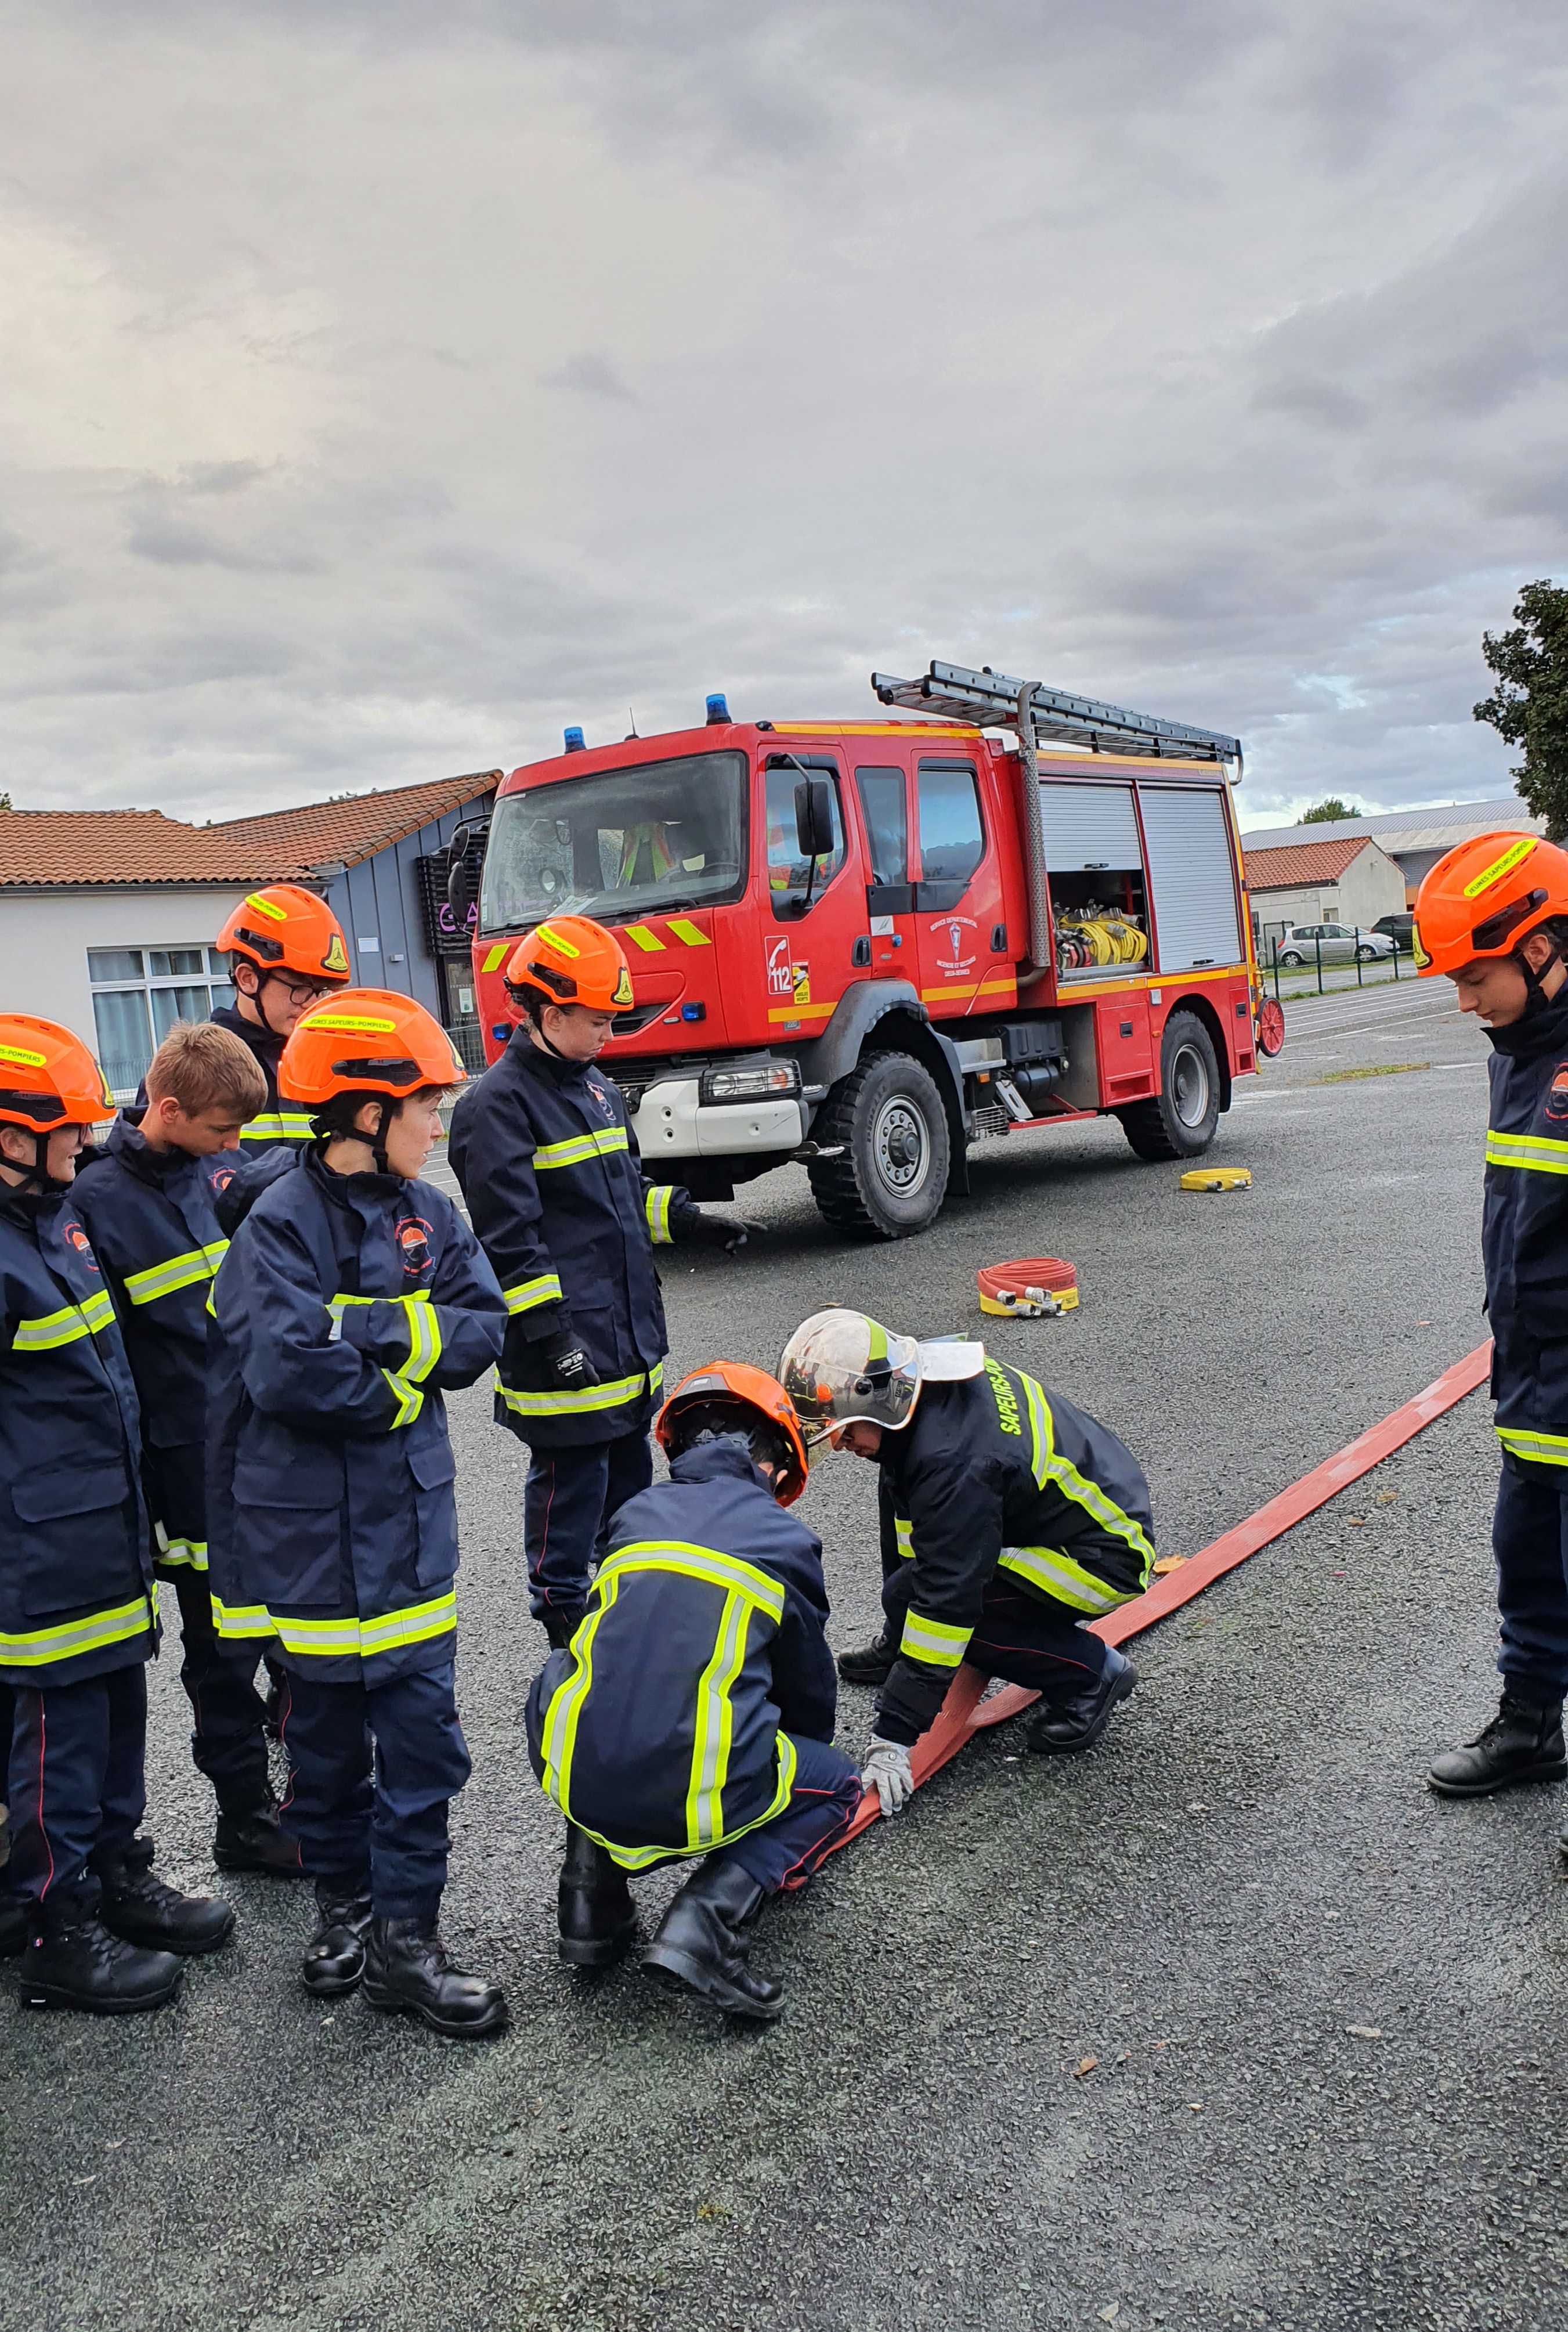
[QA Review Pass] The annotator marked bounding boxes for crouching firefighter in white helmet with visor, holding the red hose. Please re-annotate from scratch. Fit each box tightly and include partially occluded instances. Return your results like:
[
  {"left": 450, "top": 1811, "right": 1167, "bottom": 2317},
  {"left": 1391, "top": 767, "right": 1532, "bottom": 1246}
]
[{"left": 779, "top": 1311, "right": 1155, "bottom": 1814}]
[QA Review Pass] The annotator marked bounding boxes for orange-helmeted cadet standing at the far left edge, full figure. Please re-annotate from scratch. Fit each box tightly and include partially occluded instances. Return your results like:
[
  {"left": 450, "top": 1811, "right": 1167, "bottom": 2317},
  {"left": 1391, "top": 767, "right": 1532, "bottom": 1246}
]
[{"left": 0, "top": 1015, "right": 233, "bottom": 2015}]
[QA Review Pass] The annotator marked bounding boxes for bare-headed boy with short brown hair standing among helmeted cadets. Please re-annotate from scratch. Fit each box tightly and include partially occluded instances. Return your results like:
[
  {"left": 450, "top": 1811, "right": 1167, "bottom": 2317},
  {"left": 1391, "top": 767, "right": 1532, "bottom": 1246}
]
[{"left": 73, "top": 1021, "right": 301, "bottom": 1877}]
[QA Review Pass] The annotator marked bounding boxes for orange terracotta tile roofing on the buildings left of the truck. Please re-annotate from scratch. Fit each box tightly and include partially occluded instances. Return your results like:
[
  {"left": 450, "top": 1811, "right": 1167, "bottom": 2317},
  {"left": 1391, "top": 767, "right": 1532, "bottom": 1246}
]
[{"left": 0, "top": 770, "right": 501, "bottom": 891}]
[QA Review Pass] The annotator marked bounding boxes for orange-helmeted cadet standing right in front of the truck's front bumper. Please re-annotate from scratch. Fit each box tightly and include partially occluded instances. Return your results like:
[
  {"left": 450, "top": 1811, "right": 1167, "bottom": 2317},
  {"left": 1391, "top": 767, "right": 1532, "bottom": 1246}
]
[{"left": 448, "top": 914, "right": 756, "bottom": 1644}]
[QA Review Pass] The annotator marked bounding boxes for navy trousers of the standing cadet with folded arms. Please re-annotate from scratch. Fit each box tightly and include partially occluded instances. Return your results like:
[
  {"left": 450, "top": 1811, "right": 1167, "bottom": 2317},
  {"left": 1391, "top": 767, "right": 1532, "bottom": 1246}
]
[{"left": 277, "top": 1663, "right": 471, "bottom": 1933}]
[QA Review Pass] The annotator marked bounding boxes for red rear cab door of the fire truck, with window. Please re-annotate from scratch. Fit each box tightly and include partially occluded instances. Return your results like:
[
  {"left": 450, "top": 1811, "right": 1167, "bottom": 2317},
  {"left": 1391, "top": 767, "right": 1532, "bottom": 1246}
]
[{"left": 915, "top": 753, "right": 1006, "bottom": 1021}]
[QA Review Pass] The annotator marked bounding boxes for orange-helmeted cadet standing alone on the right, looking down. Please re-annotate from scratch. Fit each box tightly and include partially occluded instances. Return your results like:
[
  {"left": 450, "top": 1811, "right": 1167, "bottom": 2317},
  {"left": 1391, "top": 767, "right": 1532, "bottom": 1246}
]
[{"left": 1414, "top": 835, "right": 1568, "bottom": 1809}]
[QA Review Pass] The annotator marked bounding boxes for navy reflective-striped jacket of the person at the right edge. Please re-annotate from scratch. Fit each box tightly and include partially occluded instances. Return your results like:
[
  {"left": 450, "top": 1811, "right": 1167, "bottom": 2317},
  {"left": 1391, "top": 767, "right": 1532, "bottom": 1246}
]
[{"left": 1482, "top": 989, "right": 1568, "bottom": 1464}]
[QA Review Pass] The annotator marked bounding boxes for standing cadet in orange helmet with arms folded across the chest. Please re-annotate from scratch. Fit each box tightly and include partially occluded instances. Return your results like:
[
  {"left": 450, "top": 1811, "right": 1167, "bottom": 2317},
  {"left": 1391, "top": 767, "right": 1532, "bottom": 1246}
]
[{"left": 208, "top": 989, "right": 507, "bottom": 2041}]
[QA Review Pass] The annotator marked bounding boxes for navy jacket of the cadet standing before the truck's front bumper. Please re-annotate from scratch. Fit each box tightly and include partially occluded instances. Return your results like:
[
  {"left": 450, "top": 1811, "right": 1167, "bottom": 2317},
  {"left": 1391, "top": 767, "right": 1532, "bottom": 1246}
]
[{"left": 448, "top": 1024, "right": 695, "bottom": 1448}]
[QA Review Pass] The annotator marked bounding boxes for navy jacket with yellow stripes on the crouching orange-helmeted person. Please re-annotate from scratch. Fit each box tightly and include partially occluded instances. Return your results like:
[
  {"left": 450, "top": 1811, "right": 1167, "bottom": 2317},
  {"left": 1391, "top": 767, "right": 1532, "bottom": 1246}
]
[{"left": 528, "top": 1441, "right": 835, "bottom": 1870}]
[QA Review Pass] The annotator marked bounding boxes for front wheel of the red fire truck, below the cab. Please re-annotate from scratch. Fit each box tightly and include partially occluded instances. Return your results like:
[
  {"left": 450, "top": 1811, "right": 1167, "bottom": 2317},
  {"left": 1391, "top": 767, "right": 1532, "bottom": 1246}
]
[{"left": 807, "top": 1052, "right": 949, "bottom": 1239}]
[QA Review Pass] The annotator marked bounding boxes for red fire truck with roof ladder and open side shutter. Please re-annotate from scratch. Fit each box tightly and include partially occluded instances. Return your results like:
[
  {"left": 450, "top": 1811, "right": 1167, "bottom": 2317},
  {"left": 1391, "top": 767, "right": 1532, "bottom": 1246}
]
[{"left": 453, "top": 662, "right": 1281, "bottom": 1239}]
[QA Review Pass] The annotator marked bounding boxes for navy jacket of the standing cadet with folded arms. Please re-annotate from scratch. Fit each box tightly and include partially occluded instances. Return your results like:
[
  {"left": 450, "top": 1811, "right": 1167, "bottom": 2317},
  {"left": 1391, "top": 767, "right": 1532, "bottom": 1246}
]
[{"left": 208, "top": 1150, "right": 507, "bottom": 1684}]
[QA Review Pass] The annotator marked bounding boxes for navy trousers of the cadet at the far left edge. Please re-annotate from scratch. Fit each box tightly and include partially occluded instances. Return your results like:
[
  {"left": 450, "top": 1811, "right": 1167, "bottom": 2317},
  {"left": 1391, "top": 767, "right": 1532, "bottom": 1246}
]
[{"left": 7, "top": 1663, "right": 147, "bottom": 1903}]
